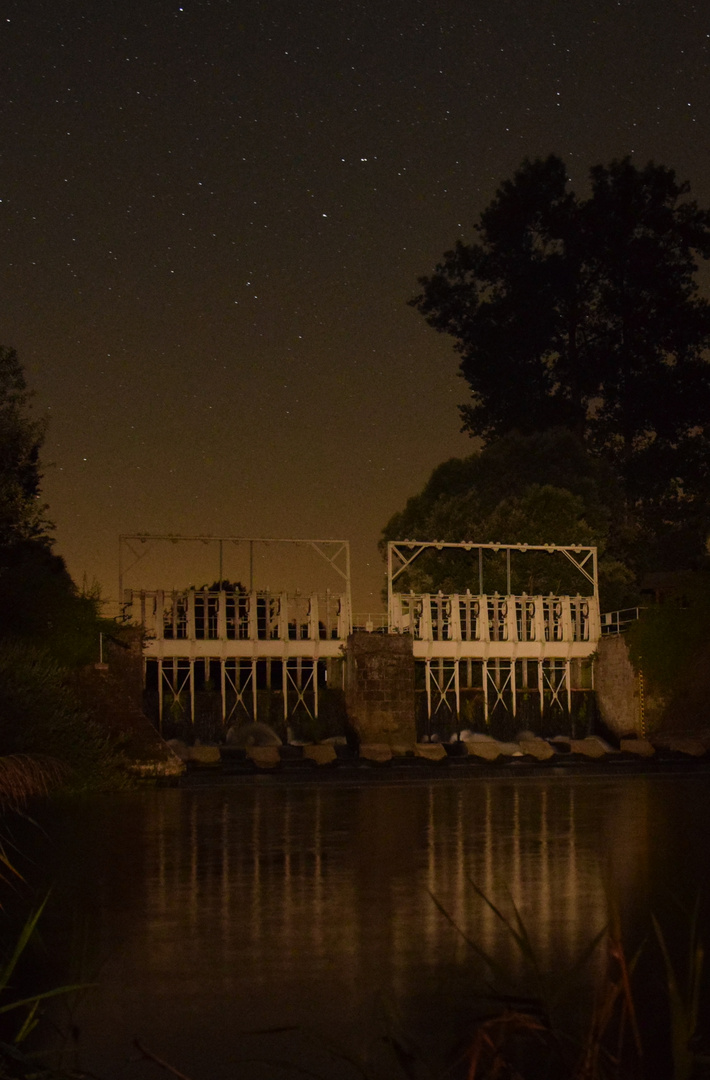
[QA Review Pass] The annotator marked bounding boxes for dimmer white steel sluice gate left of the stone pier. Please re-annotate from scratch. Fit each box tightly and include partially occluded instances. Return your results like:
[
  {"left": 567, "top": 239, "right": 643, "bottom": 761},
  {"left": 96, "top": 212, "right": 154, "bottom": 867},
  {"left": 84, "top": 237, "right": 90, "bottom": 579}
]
[{"left": 121, "top": 536, "right": 351, "bottom": 723}]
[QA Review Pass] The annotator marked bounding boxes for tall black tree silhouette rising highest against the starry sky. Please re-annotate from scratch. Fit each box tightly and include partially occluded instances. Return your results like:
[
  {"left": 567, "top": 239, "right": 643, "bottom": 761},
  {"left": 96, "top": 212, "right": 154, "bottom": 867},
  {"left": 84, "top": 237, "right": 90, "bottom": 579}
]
[{"left": 411, "top": 157, "right": 710, "bottom": 562}]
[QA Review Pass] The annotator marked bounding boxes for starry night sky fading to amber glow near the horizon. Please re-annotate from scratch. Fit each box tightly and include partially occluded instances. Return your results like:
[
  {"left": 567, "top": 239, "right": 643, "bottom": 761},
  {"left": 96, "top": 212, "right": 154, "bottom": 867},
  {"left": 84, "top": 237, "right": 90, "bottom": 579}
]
[{"left": 0, "top": 0, "right": 710, "bottom": 611}]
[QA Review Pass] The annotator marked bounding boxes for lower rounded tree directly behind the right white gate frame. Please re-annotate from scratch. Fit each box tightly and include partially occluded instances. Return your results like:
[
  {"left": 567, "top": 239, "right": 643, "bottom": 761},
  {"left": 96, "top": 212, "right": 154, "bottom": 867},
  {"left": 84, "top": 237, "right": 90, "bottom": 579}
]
[{"left": 381, "top": 428, "right": 635, "bottom": 608}]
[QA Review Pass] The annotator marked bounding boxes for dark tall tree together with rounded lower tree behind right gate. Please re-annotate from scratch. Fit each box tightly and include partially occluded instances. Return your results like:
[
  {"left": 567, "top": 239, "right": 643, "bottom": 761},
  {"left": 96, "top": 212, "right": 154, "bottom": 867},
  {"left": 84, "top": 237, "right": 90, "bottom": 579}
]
[{"left": 384, "top": 157, "right": 710, "bottom": 609}]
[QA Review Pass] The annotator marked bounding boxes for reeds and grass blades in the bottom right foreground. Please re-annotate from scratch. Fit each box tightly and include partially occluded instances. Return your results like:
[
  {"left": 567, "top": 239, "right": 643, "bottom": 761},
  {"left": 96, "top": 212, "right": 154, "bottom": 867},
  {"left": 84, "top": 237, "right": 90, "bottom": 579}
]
[{"left": 423, "top": 879, "right": 710, "bottom": 1080}]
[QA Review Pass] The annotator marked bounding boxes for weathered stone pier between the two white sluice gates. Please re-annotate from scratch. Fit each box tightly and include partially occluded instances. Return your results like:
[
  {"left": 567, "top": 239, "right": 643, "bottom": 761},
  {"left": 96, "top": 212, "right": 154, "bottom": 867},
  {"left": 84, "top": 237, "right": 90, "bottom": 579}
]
[{"left": 345, "top": 632, "right": 416, "bottom": 746}]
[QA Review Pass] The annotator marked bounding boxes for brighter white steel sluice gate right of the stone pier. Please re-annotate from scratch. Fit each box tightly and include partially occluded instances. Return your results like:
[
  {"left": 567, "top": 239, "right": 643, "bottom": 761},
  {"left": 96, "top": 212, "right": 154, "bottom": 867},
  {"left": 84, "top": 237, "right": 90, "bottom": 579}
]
[{"left": 387, "top": 540, "right": 601, "bottom": 729}]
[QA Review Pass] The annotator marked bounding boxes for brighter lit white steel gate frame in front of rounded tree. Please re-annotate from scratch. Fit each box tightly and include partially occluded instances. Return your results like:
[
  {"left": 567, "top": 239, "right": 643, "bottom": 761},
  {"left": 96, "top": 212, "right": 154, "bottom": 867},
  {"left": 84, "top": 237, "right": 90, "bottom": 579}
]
[{"left": 387, "top": 540, "right": 601, "bottom": 718}]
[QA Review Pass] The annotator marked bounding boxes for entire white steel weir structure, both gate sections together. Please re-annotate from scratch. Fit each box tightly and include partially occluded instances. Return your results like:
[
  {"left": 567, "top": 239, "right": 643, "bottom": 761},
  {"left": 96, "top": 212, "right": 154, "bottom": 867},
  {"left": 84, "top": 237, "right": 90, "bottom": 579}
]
[{"left": 119, "top": 535, "right": 601, "bottom": 738}]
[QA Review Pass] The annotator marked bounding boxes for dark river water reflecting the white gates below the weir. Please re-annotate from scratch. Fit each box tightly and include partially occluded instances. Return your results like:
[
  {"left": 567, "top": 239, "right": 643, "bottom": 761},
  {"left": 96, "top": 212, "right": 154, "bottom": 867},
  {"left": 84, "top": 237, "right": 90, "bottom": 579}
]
[{"left": 37, "top": 777, "right": 710, "bottom": 1080}]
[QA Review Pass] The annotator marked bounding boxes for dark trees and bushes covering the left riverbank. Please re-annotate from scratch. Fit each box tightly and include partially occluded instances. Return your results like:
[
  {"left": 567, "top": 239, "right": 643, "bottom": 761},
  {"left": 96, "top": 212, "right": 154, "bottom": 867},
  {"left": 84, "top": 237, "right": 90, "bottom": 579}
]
[{"left": 0, "top": 347, "right": 130, "bottom": 807}]
